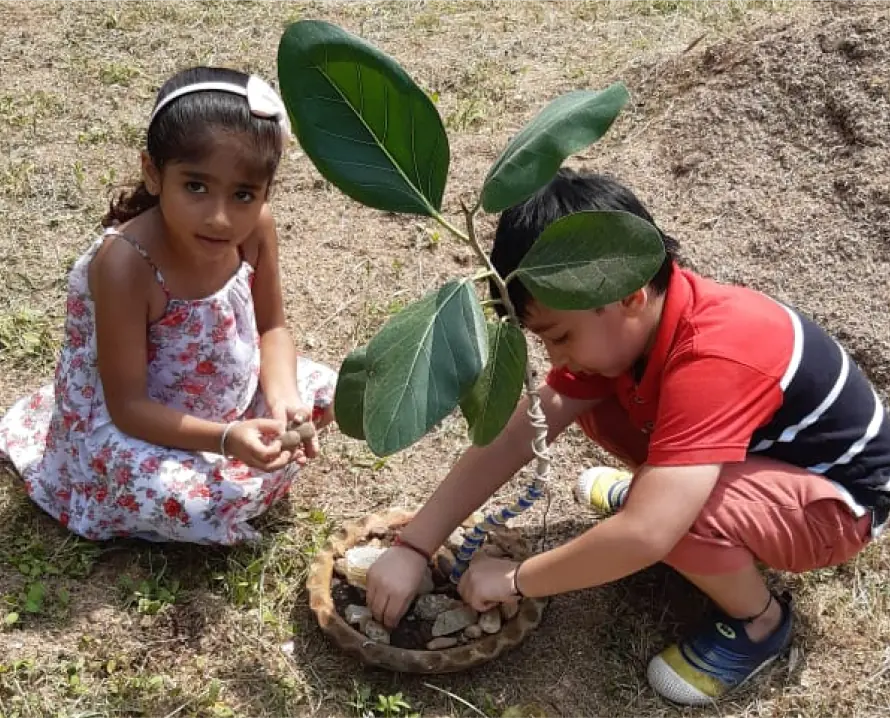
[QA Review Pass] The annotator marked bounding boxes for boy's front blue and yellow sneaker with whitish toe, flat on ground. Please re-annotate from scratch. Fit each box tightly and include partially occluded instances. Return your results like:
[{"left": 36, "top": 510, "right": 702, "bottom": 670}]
[{"left": 647, "top": 598, "right": 792, "bottom": 706}]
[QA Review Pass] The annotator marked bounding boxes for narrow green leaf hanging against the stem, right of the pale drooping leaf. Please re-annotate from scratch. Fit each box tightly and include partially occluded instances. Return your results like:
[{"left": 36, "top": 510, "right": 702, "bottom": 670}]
[{"left": 460, "top": 322, "right": 528, "bottom": 446}]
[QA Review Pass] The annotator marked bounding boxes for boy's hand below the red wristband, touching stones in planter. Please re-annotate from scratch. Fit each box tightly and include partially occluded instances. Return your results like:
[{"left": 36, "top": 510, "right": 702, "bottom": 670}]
[{"left": 367, "top": 546, "right": 427, "bottom": 629}]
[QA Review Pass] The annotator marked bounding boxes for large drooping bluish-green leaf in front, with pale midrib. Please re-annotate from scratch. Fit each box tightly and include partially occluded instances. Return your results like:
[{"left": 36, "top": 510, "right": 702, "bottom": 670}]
[{"left": 364, "top": 280, "right": 488, "bottom": 456}]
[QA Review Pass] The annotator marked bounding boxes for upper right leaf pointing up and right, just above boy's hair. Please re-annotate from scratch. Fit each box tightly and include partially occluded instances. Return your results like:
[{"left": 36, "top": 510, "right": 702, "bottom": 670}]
[{"left": 482, "top": 82, "right": 629, "bottom": 213}]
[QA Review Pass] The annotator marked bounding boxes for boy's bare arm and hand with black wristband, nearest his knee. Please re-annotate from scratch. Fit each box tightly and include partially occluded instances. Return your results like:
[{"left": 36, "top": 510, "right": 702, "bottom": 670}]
[{"left": 460, "top": 464, "right": 721, "bottom": 610}]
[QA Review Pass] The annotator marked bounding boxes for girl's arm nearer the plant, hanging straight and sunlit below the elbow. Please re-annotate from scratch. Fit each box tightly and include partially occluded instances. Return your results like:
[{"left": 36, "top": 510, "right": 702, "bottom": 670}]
[{"left": 253, "top": 207, "right": 311, "bottom": 421}]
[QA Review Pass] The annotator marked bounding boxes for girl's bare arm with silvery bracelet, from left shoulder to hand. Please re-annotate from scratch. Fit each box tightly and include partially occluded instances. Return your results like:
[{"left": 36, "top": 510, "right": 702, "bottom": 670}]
[{"left": 89, "top": 241, "right": 280, "bottom": 467}]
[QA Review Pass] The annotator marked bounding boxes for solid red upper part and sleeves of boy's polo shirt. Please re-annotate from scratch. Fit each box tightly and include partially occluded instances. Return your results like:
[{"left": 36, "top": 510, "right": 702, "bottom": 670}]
[{"left": 547, "top": 269, "right": 794, "bottom": 466}]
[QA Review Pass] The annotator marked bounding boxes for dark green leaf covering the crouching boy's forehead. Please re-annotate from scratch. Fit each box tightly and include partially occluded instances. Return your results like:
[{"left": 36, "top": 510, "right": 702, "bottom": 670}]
[{"left": 507, "top": 211, "right": 664, "bottom": 309}]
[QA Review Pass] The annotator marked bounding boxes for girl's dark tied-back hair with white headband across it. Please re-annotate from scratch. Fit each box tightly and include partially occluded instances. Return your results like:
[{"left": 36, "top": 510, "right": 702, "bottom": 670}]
[{"left": 102, "top": 67, "right": 283, "bottom": 227}]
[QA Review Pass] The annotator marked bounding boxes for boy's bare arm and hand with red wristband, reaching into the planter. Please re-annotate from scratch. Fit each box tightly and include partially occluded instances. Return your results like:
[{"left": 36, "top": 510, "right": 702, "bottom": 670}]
[{"left": 368, "top": 385, "right": 596, "bottom": 626}]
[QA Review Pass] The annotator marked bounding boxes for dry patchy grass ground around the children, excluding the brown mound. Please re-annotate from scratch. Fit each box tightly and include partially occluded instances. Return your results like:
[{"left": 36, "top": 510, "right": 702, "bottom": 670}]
[{"left": 0, "top": 0, "right": 890, "bottom": 718}]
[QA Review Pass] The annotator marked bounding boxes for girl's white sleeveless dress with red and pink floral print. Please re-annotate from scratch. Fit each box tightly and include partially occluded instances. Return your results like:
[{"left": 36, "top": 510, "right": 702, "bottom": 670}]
[{"left": 0, "top": 230, "right": 336, "bottom": 544}]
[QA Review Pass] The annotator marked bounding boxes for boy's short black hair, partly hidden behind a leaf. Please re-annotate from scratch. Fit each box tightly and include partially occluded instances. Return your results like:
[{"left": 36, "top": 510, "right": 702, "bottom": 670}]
[{"left": 489, "top": 168, "right": 680, "bottom": 320}]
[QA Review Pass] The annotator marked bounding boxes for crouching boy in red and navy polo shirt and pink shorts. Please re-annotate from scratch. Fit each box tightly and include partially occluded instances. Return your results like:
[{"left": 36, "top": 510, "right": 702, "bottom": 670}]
[{"left": 368, "top": 170, "right": 890, "bottom": 705}]
